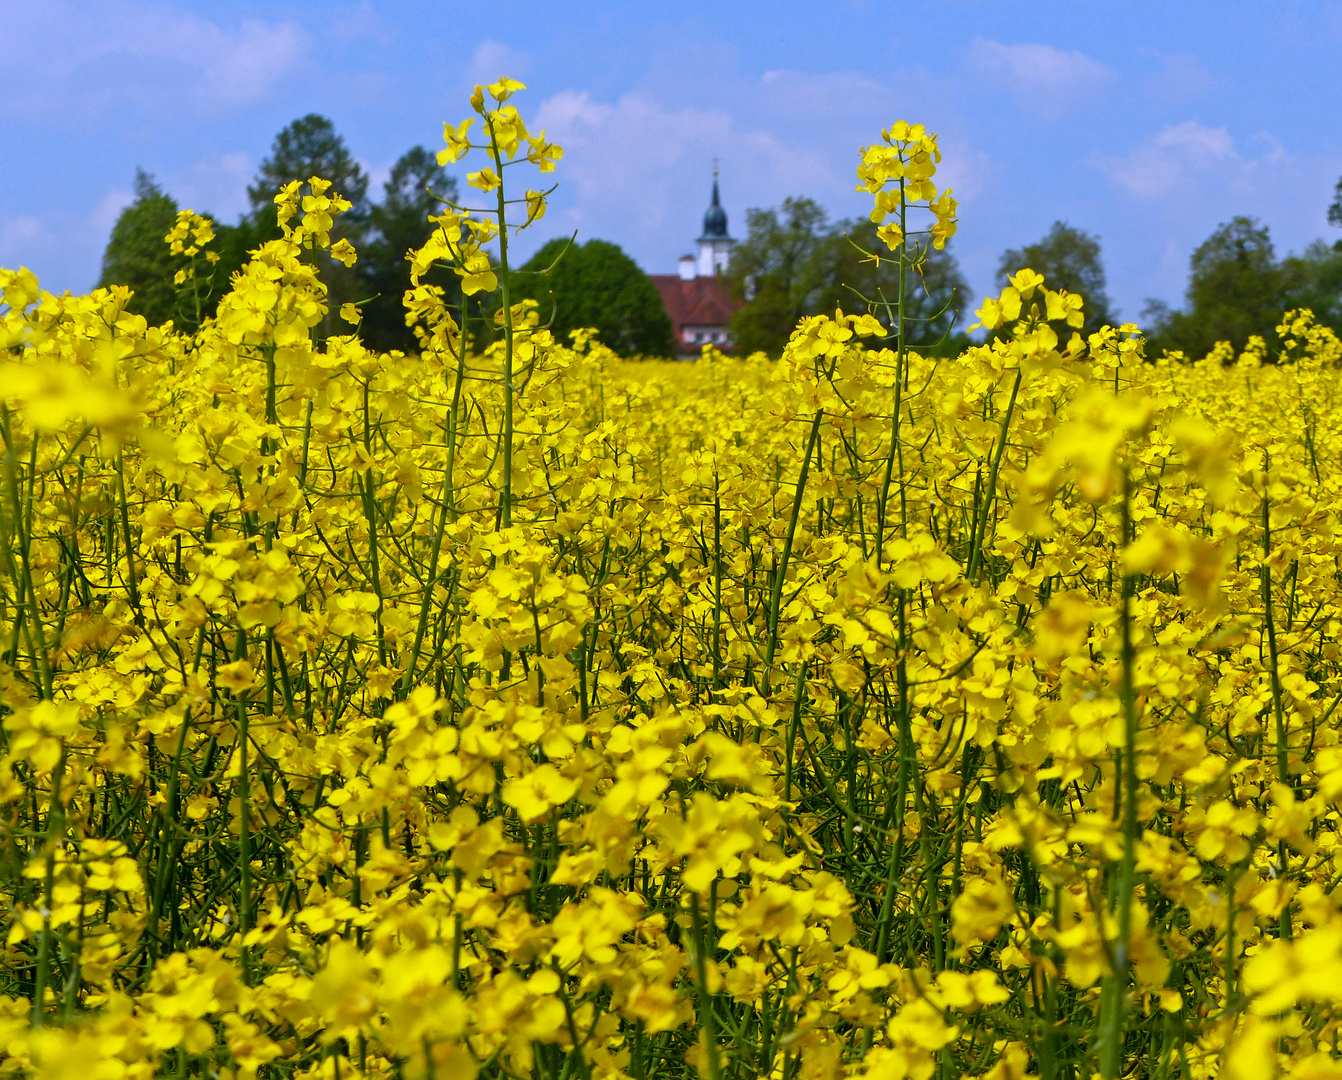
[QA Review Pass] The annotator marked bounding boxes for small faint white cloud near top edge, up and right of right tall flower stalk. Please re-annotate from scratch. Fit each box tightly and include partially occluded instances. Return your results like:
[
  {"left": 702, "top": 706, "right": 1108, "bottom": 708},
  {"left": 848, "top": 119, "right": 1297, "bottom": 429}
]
[{"left": 966, "top": 38, "right": 1118, "bottom": 119}]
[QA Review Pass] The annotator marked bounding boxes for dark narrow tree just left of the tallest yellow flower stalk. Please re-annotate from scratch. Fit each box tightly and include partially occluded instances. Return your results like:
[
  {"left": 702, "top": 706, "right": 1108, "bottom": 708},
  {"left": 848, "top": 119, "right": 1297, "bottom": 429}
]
[{"left": 356, "top": 146, "right": 460, "bottom": 350}]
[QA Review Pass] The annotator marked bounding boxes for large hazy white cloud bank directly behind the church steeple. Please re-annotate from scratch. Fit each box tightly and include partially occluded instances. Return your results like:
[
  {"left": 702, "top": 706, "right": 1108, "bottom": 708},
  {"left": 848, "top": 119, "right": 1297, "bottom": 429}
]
[{"left": 523, "top": 70, "right": 997, "bottom": 272}]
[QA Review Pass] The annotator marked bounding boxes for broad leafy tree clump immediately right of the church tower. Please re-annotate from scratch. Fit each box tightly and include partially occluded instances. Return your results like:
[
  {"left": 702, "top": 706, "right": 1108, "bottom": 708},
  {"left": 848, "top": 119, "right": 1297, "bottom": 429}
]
[{"left": 727, "top": 196, "right": 968, "bottom": 354}]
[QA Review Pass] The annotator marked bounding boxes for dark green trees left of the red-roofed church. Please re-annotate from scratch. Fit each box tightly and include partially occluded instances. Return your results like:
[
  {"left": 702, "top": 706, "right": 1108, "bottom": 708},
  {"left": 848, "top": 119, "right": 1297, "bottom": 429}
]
[{"left": 98, "top": 113, "right": 671, "bottom": 356}]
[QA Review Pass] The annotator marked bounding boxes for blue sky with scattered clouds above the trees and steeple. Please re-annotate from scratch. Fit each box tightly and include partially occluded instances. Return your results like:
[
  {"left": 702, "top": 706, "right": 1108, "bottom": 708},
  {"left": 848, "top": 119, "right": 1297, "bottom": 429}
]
[{"left": 0, "top": 0, "right": 1342, "bottom": 318}]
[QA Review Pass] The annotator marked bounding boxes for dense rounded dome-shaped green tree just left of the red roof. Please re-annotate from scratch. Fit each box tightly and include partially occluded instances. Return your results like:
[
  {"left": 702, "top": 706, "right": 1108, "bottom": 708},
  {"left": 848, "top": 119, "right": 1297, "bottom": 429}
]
[{"left": 510, "top": 239, "right": 671, "bottom": 357}]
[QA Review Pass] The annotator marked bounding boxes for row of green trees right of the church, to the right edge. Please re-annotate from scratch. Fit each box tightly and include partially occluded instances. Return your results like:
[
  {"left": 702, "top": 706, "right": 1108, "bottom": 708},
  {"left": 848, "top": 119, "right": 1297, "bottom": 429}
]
[{"left": 729, "top": 180, "right": 1342, "bottom": 357}]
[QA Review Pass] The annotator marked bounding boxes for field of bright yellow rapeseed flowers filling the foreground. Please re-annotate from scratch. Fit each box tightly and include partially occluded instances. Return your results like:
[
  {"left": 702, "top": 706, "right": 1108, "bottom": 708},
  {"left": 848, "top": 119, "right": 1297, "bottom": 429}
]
[{"left": 0, "top": 92, "right": 1342, "bottom": 1080}]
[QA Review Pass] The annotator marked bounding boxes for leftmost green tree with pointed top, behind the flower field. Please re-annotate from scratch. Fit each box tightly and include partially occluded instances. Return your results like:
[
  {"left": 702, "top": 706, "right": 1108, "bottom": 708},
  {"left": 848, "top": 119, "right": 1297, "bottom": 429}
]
[{"left": 98, "top": 169, "right": 185, "bottom": 326}]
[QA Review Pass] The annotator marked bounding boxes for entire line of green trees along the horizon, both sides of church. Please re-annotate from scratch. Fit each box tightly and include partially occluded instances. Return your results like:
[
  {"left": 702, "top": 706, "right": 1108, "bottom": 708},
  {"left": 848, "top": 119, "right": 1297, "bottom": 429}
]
[{"left": 99, "top": 113, "right": 1342, "bottom": 357}]
